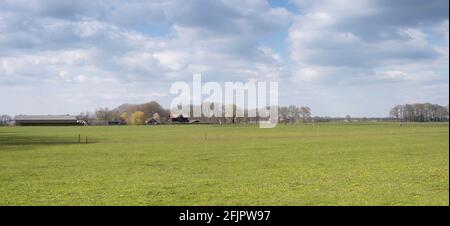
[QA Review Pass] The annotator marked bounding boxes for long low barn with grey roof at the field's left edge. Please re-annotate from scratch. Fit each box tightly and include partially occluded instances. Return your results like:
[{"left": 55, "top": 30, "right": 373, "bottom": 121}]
[{"left": 14, "top": 115, "right": 79, "bottom": 126}]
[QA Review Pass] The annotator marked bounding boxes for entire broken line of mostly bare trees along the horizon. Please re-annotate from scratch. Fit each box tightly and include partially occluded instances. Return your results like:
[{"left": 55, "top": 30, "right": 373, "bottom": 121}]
[{"left": 0, "top": 101, "right": 449, "bottom": 126}]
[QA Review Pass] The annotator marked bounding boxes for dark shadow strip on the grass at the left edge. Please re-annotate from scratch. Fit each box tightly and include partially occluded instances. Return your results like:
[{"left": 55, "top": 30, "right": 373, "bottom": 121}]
[{"left": 0, "top": 133, "right": 98, "bottom": 150}]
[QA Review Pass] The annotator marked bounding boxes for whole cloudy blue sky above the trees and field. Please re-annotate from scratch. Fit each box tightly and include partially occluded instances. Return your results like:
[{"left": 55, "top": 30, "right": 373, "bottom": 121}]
[{"left": 0, "top": 0, "right": 449, "bottom": 116}]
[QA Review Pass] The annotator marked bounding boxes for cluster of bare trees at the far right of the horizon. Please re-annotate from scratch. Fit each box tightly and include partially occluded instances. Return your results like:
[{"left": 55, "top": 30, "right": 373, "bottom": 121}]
[{"left": 390, "top": 103, "right": 449, "bottom": 122}]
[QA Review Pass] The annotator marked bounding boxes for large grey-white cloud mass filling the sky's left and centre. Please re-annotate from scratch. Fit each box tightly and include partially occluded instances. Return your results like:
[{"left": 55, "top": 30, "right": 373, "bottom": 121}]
[{"left": 0, "top": 0, "right": 291, "bottom": 113}]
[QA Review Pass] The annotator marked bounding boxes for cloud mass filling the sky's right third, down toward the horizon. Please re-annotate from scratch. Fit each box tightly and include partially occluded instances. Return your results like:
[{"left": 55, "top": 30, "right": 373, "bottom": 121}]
[{"left": 288, "top": 0, "right": 448, "bottom": 115}]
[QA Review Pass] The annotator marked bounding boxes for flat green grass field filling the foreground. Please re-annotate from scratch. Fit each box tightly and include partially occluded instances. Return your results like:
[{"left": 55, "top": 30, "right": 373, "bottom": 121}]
[{"left": 0, "top": 123, "right": 449, "bottom": 205}]
